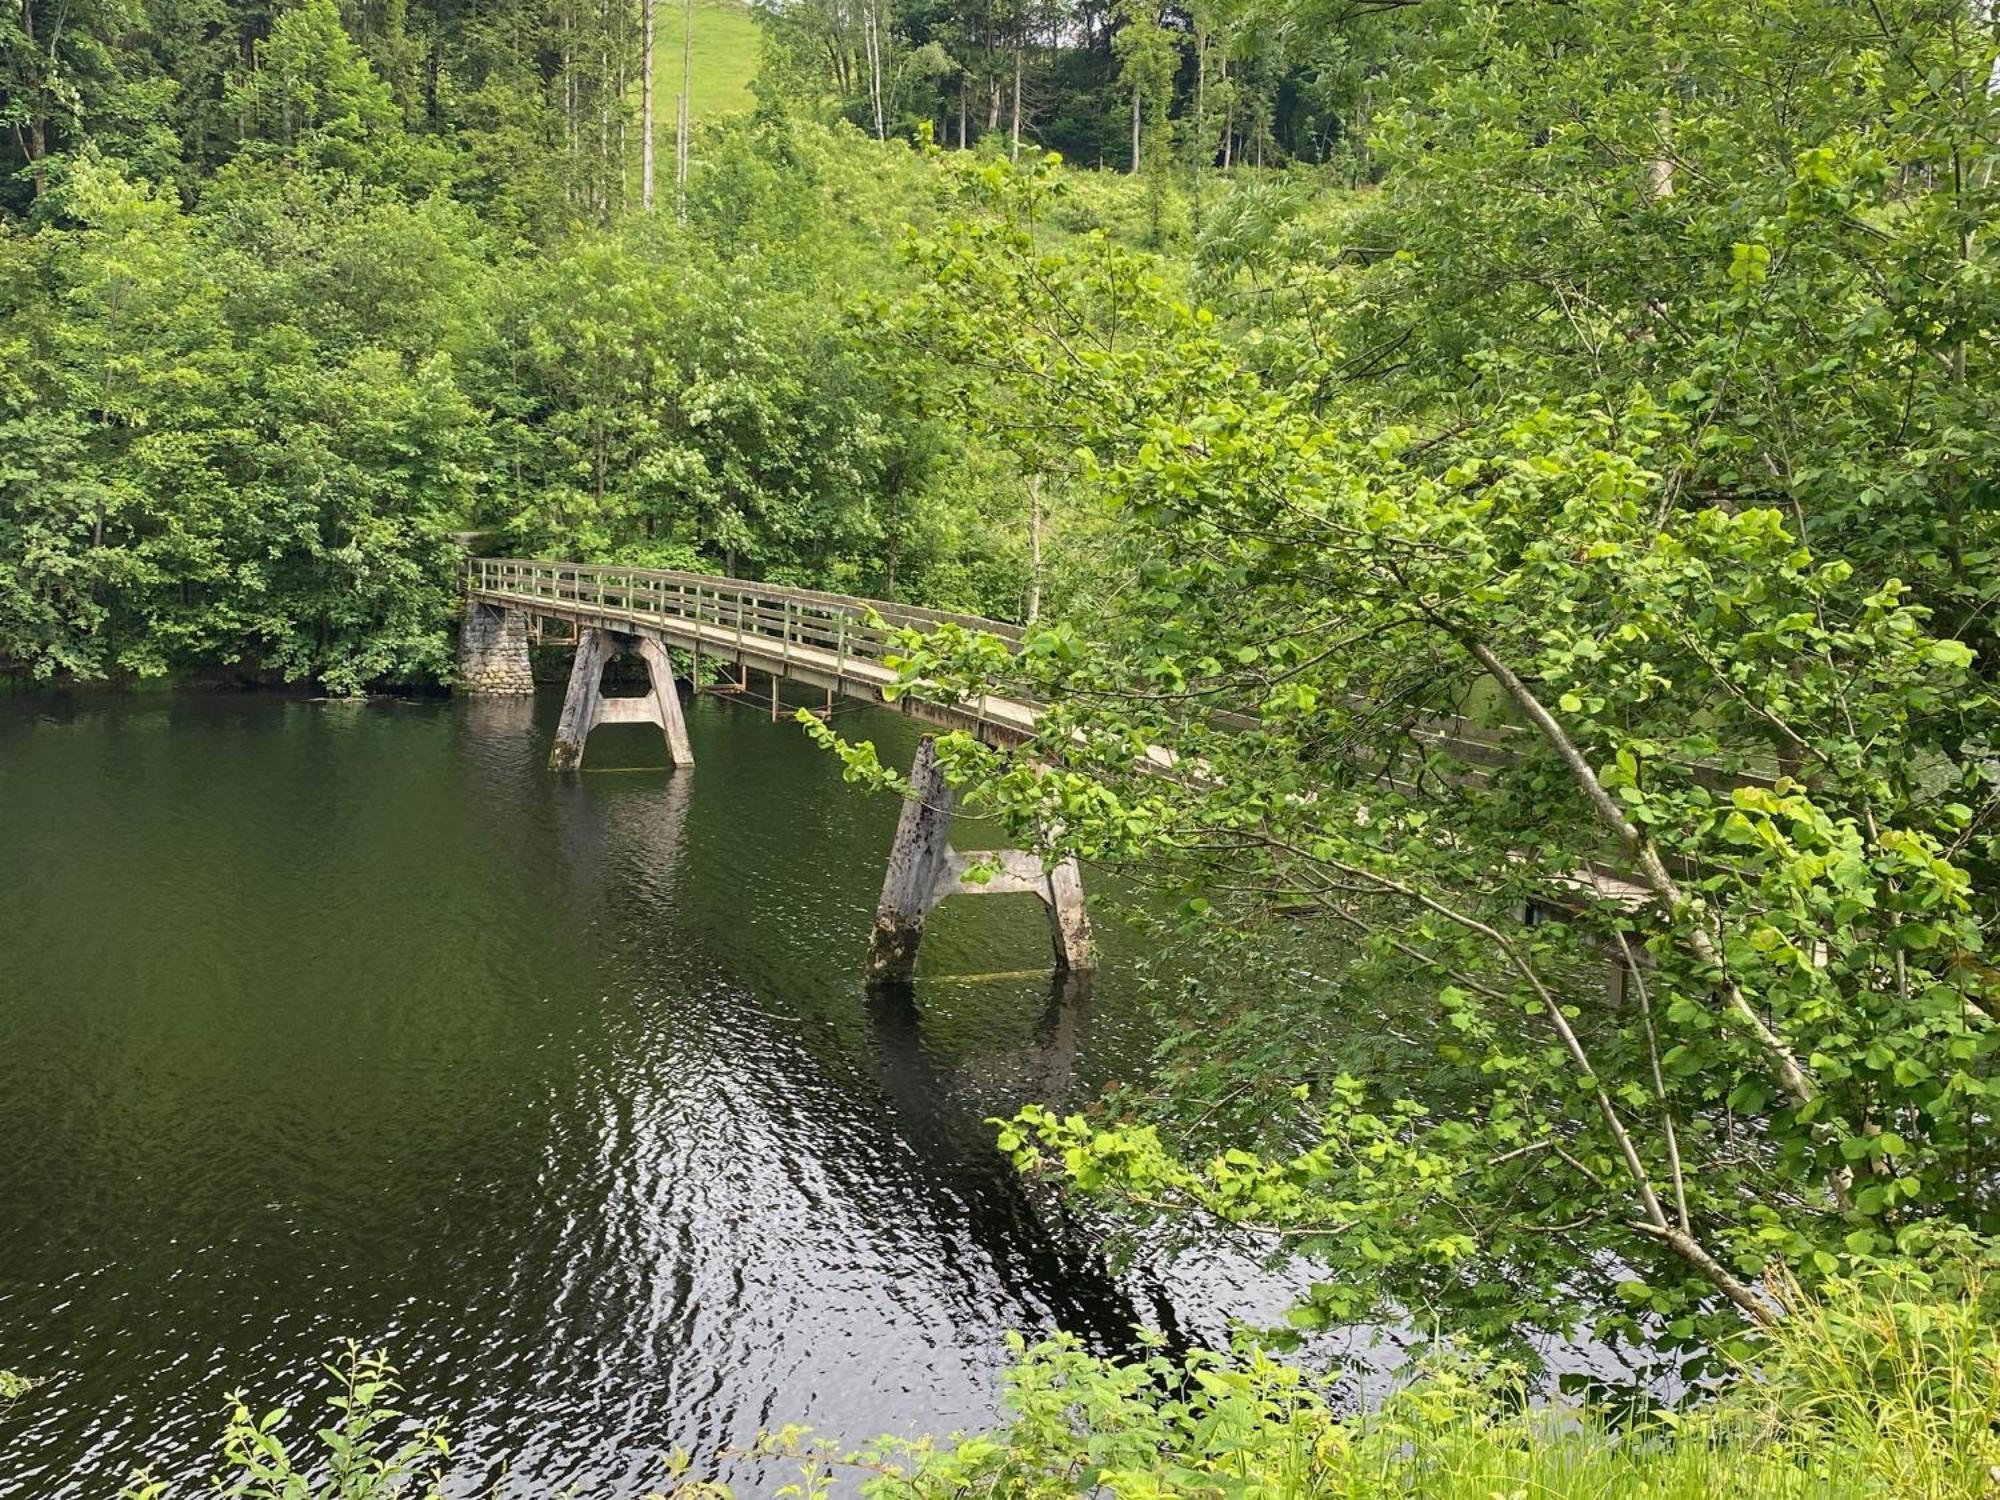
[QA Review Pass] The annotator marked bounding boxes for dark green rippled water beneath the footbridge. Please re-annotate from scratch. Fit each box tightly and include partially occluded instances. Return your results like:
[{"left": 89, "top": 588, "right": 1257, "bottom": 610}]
[{"left": 0, "top": 694, "right": 1232, "bottom": 1500}]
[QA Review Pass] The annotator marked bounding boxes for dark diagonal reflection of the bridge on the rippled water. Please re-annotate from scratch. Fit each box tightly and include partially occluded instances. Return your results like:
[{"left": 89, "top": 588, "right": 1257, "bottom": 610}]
[{"left": 460, "top": 698, "right": 1172, "bottom": 1352}]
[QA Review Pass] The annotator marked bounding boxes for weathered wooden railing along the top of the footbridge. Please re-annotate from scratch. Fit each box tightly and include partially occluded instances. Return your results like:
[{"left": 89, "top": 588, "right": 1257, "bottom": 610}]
[{"left": 466, "top": 558, "right": 1020, "bottom": 676}]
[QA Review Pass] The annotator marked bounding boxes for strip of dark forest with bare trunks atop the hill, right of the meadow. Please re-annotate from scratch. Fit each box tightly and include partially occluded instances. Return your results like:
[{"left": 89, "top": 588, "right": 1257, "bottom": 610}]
[{"left": 764, "top": 0, "right": 1392, "bottom": 180}]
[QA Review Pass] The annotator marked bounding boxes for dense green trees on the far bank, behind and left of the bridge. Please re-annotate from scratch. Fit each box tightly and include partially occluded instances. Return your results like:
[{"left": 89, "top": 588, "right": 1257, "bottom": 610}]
[{"left": 0, "top": 0, "right": 1120, "bottom": 692}]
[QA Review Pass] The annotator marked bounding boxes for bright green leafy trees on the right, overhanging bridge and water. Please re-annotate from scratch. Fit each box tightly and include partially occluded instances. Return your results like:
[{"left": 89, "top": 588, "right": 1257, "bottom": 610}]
[{"left": 808, "top": 0, "right": 2000, "bottom": 1348}]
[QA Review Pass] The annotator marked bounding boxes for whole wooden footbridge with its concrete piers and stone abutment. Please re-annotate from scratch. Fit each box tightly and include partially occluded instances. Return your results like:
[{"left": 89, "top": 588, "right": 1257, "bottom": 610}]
[{"left": 458, "top": 558, "right": 1094, "bottom": 982}]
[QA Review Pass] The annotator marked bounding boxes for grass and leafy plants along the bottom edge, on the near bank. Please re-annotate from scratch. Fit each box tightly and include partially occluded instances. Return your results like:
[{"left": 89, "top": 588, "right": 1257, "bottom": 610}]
[{"left": 101, "top": 1276, "right": 2000, "bottom": 1500}]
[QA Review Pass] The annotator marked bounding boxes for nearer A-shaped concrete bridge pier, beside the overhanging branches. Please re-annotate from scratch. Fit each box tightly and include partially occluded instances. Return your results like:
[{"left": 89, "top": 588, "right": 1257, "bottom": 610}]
[{"left": 868, "top": 736, "right": 1096, "bottom": 984}]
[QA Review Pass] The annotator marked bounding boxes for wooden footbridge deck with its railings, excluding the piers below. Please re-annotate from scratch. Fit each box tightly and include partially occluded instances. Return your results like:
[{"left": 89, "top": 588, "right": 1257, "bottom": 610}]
[{"left": 466, "top": 558, "right": 1040, "bottom": 740}]
